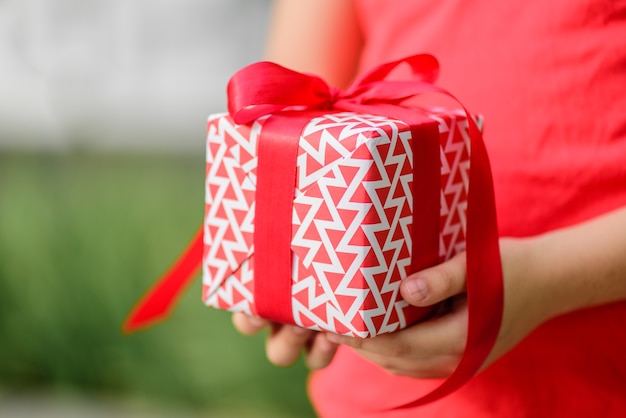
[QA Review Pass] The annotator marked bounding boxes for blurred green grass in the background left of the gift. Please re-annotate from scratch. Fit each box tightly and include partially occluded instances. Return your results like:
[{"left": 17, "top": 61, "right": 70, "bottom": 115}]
[{"left": 0, "top": 153, "right": 313, "bottom": 417}]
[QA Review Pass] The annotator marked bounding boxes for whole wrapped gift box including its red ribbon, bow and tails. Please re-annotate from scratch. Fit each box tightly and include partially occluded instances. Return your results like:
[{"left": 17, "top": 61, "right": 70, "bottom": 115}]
[{"left": 123, "top": 54, "right": 504, "bottom": 408}]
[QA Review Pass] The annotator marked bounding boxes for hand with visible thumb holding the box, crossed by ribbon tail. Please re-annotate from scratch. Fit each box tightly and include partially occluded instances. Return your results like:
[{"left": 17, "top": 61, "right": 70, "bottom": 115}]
[{"left": 327, "top": 240, "right": 551, "bottom": 378}]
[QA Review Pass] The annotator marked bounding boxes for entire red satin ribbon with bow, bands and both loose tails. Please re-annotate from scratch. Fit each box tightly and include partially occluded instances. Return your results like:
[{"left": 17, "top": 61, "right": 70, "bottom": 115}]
[{"left": 124, "top": 55, "right": 503, "bottom": 408}]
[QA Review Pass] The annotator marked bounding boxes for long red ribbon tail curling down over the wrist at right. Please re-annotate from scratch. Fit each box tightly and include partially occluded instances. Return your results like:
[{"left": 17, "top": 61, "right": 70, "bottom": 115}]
[{"left": 386, "top": 103, "right": 504, "bottom": 409}]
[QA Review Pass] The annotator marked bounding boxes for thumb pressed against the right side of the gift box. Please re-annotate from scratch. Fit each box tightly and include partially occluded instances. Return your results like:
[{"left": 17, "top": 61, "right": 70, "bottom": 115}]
[{"left": 400, "top": 252, "right": 466, "bottom": 306}]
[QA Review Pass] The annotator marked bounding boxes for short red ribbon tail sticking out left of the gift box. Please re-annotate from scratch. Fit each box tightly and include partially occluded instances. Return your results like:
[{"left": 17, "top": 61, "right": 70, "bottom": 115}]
[{"left": 122, "top": 228, "right": 204, "bottom": 334}]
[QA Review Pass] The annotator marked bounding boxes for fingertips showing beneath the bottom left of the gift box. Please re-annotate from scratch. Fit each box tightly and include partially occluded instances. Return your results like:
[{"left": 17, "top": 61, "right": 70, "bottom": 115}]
[{"left": 233, "top": 313, "right": 337, "bottom": 370}]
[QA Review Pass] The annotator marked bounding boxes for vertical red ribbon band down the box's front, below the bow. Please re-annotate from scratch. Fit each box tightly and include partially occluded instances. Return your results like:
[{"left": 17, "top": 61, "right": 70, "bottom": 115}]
[{"left": 253, "top": 112, "right": 312, "bottom": 324}]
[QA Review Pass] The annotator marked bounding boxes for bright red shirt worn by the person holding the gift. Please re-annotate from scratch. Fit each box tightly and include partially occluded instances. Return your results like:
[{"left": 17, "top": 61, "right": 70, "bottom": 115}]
[{"left": 310, "top": 0, "right": 626, "bottom": 417}]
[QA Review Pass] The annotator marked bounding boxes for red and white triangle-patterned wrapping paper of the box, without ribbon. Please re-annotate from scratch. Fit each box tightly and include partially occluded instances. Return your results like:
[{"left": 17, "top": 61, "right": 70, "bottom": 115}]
[{"left": 202, "top": 109, "right": 470, "bottom": 338}]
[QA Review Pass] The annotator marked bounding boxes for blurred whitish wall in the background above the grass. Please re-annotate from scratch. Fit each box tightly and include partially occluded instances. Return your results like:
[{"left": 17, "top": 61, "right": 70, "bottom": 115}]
[{"left": 0, "top": 0, "right": 269, "bottom": 152}]
